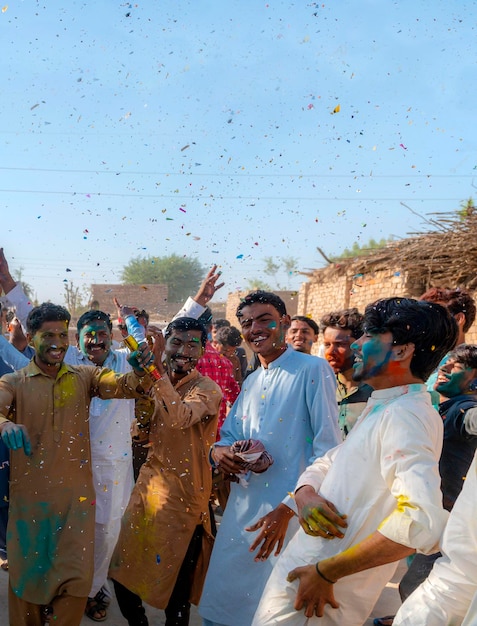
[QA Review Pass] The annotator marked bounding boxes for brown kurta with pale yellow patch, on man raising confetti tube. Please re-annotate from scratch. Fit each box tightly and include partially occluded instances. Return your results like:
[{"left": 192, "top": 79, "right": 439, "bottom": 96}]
[{"left": 110, "top": 370, "right": 222, "bottom": 609}]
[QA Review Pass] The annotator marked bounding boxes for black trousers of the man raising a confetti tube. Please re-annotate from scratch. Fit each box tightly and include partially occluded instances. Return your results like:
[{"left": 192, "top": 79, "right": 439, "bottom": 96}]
[{"left": 113, "top": 525, "right": 204, "bottom": 626}]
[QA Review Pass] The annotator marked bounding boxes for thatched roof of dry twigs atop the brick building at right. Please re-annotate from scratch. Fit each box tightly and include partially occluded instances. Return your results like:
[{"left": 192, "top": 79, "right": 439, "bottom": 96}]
[{"left": 306, "top": 206, "right": 477, "bottom": 290}]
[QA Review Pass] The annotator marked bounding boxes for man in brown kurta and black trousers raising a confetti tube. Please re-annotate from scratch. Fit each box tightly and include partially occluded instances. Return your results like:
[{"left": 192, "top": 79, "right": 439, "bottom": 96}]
[{"left": 110, "top": 318, "right": 222, "bottom": 626}]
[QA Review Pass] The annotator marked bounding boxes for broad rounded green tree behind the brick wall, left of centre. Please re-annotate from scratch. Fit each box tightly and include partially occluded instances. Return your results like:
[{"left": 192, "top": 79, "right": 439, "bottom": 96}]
[{"left": 121, "top": 254, "right": 205, "bottom": 302}]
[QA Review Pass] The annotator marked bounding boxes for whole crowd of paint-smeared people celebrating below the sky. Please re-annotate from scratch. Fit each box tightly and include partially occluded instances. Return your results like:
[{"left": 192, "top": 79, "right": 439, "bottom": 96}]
[{"left": 0, "top": 249, "right": 477, "bottom": 626}]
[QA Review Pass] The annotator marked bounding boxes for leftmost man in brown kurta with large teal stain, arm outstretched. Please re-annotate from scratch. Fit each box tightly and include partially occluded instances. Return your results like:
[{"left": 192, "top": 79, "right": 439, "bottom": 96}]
[{"left": 0, "top": 303, "right": 151, "bottom": 626}]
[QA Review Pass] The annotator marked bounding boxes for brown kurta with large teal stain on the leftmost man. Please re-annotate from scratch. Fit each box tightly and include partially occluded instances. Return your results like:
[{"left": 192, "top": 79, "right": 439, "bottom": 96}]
[{"left": 0, "top": 361, "right": 148, "bottom": 604}]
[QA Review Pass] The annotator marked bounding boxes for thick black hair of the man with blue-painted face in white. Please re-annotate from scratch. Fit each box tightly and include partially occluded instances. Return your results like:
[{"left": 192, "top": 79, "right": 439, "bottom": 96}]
[{"left": 363, "top": 298, "right": 458, "bottom": 381}]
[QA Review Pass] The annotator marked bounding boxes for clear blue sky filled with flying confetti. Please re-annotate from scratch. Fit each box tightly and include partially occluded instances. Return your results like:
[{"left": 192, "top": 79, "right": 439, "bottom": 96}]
[{"left": 0, "top": 0, "right": 477, "bottom": 302}]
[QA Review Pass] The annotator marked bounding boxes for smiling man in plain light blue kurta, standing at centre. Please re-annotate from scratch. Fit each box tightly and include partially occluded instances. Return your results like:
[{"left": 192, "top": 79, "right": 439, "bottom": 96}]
[{"left": 199, "top": 292, "right": 341, "bottom": 626}]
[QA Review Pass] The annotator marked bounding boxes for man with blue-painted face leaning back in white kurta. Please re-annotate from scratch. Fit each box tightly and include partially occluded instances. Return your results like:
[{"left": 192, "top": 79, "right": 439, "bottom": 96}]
[{"left": 253, "top": 298, "right": 457, "bottom": 626}]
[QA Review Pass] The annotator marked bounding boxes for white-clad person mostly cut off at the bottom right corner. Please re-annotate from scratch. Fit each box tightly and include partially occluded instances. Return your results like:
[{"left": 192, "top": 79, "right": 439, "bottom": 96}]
[{"left": 394, "top": 448, "right": 477, "bottom": 626}]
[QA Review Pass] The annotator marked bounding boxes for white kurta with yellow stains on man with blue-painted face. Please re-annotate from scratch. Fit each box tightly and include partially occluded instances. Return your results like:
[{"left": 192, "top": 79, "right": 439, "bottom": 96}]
[{"left": 253, "top": 385, "right": 447, "bottom": 626}]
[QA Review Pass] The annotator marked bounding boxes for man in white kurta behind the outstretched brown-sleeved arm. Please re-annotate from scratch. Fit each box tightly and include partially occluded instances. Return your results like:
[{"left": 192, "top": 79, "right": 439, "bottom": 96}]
[{"left": 69, "top": 310, "right": 139, "bottom": 620}]
